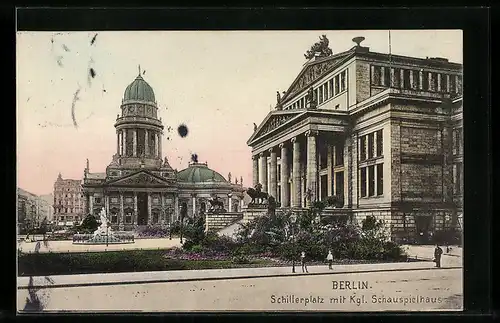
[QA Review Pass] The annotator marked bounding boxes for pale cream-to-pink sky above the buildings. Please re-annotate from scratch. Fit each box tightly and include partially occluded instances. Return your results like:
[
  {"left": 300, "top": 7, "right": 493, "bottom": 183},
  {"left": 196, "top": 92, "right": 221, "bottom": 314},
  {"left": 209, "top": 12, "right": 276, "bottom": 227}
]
[{"left": 16, "top": 30, "right": 462, "bottom": 194}]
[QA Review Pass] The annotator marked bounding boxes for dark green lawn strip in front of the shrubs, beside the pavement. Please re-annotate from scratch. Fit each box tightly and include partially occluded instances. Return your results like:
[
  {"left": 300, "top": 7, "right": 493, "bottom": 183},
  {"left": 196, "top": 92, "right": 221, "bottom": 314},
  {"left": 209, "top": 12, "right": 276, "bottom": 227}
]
[{"left": 18, "top": 250, "right": 275, "bottom": 276}]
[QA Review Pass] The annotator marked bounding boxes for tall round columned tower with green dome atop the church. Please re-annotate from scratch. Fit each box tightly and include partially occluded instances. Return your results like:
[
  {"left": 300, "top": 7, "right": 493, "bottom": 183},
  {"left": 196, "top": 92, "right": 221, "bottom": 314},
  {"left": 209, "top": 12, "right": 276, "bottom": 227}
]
[{"left": 113, "top": 66, "right": 163, "bottom": 169}]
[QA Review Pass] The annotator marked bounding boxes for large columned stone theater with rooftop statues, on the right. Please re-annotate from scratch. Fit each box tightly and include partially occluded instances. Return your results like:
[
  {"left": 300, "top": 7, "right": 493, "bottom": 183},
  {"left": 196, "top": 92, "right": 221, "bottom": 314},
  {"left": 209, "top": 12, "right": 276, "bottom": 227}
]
[{"left": 247, "top": 37, "right": 463, "bottom": 239}]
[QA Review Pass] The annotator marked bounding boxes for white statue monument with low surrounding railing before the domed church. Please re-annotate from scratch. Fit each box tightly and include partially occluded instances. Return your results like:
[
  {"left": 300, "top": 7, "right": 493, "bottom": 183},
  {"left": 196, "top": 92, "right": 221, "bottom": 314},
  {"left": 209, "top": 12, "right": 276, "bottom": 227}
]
[{"left": 73, "top": 208, "right": 135, "bottom": 245}]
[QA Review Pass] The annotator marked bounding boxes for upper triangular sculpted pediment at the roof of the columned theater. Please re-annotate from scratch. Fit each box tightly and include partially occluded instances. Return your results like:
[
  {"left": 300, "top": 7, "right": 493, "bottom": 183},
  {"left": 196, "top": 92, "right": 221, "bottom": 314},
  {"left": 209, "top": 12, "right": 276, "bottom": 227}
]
[{"left": 283, "top": 52, "right": 350, "bottom": 101}]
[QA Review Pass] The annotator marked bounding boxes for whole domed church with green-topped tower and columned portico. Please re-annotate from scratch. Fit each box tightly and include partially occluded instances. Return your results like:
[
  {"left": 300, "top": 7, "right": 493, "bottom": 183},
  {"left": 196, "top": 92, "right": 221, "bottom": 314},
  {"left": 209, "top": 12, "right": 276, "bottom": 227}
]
[{"left": 82, "top": 72, "right": 245, "bottom": 230}]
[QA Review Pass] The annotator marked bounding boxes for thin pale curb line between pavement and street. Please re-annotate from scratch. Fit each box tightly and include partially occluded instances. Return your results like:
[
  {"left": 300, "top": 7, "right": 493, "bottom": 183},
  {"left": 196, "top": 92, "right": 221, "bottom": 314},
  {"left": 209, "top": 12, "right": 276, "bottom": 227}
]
[{"left": 17, "top": 266, "right": 463, "bottom": 289}]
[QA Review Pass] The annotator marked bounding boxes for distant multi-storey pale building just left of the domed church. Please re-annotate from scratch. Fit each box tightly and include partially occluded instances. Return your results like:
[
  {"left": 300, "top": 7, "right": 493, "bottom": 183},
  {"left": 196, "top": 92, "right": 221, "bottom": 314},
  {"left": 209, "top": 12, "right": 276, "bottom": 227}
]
[{"left": 53, "top": 174, "right": 85, "bottom": 226}]
